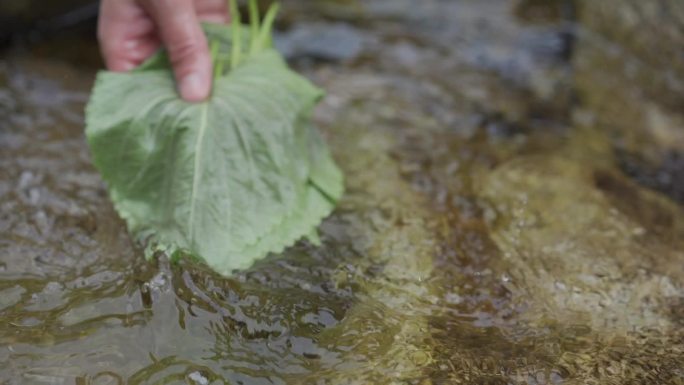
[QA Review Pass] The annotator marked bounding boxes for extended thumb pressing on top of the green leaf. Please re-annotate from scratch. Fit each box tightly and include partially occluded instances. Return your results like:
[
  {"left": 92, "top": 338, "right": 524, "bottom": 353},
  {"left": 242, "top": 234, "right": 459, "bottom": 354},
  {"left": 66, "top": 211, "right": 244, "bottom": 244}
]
[{"left": 146, "top": 0, "right": 212, "bottom": 102}]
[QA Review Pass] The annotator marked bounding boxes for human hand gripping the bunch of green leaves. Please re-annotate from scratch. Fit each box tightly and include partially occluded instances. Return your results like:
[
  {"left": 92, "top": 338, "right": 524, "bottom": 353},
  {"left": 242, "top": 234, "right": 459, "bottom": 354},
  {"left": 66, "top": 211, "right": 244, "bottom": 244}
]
[{"left": 98, "top": 0, "right": 229, "bottom": 102}]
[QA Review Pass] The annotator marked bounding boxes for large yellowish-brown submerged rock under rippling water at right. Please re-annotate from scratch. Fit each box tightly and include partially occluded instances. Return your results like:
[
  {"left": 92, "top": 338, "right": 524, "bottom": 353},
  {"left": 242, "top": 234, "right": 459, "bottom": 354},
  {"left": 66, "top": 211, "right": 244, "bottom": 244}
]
[{"left": 483, "top": 152, "right": 684, "bottom": 333}]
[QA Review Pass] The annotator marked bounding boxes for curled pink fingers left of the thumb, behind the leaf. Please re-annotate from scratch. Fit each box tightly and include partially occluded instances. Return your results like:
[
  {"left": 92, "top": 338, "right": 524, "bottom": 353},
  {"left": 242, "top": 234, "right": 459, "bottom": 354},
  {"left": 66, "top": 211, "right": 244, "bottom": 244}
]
[{"left": 98, "top": 0, "right": 159, "bottom": 72}]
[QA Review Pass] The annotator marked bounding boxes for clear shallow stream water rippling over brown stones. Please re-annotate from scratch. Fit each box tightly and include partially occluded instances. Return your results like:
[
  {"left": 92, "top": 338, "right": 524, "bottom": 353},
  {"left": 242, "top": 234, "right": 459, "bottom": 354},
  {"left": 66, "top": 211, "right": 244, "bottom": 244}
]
[{"left": 0, "top": 0, "right": 684, "bottom": 385}]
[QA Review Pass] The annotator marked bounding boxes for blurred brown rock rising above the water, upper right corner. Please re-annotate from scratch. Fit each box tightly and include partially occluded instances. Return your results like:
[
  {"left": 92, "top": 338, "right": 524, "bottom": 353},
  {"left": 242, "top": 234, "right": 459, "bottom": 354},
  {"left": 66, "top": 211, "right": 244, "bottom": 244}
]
[{"left": 574, "top": 0, "right": 684, "bottom": 158}]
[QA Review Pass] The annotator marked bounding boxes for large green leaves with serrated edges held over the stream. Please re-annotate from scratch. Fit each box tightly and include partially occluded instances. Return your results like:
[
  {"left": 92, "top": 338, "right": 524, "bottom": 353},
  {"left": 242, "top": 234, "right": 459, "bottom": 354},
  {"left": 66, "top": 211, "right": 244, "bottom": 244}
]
[{"left": 86, "top": 9, "right": 343, "bottom": 275}]
